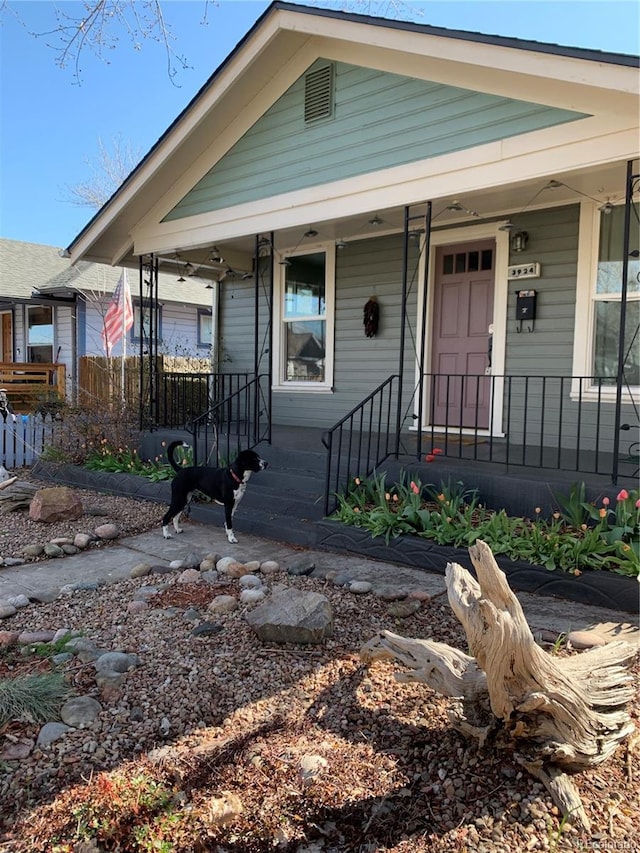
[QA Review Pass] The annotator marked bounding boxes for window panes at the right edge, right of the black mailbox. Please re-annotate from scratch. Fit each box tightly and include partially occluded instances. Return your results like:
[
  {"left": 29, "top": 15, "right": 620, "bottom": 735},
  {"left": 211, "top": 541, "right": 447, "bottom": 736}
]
[{"left": 593, "top": 204, "right": 640, "bottom": 386}]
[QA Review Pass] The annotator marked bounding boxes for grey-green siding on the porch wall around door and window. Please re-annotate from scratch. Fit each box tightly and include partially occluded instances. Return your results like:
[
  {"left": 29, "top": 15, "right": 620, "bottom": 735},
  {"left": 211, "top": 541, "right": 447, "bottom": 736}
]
[{"left": 221, "top": 211, "right": 633, "bottom": 449}]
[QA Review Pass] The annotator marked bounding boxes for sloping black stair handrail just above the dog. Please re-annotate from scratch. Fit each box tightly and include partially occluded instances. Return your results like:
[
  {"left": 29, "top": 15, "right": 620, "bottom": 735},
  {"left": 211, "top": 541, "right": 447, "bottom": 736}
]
[{"left": 187, "top": 374, "right": 271, "bottom": 467}]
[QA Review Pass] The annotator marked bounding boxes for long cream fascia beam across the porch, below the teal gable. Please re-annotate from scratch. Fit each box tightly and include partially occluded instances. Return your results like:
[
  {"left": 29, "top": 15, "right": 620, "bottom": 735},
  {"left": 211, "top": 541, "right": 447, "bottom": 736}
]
[{"left": 134, "top": 119, "right": 638, "bottom": 254}]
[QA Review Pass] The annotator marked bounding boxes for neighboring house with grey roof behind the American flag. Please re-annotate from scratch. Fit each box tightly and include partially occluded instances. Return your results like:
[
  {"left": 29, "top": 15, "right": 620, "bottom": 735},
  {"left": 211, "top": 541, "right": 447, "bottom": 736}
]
[{"left": 0, "top": 239, "right": 218, "bottom": 395}]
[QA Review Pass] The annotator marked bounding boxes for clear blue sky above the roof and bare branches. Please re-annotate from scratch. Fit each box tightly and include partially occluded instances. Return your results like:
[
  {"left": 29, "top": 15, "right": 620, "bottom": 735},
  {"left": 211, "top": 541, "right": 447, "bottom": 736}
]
[{"left": 0, "top": 0, "right": 640, "bottom": 247}]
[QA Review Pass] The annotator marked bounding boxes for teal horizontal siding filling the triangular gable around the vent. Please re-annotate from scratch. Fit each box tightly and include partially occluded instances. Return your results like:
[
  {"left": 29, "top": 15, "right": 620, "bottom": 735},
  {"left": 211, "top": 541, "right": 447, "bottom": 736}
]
[{"left": 165, "top": 63, "right": 584, "bottom": 221}]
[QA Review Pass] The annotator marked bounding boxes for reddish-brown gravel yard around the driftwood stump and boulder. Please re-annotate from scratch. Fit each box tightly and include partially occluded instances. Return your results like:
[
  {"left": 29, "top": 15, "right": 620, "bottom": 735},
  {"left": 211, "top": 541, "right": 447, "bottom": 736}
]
[{"left": 0, "top": 476, "right": 640, "bottom": 853}]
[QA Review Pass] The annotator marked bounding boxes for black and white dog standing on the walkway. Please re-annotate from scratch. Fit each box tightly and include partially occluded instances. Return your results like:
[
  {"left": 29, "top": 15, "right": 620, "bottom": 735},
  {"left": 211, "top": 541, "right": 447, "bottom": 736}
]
[{"left": 162, "top": 441, "right": 268, "bottom": 543}]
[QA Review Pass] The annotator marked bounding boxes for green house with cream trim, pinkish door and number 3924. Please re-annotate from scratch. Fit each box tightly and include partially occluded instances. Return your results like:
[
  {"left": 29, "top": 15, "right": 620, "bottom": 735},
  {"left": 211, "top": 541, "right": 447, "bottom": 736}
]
[{"left": 62, "top": 2, "right": 640, "bottom": 482}]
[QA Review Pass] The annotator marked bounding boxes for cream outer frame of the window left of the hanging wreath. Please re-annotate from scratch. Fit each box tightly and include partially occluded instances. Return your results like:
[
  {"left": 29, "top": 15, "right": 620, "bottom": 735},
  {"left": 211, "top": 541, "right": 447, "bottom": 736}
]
[{"left": 272, "top": 242, "right": 336, "bottom": 394}]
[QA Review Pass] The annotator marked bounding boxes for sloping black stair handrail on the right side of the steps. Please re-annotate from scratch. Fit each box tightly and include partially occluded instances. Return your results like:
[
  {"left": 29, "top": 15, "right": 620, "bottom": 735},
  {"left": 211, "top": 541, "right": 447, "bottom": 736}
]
[{"left": 322, "top": 374, "right": 400, "bottom": 515}]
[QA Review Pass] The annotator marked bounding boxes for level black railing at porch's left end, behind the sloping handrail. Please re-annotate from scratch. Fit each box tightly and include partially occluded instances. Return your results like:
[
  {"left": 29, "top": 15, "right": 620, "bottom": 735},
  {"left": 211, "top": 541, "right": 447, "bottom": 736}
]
[{"left": 157, "top": 371, "right": 253, "bottom": 429}]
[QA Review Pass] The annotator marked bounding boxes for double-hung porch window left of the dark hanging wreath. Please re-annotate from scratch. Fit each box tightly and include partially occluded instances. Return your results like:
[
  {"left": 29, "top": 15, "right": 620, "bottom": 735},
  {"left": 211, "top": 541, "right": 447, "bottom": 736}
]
[{"left": 274, "top": 248, "right": 334, "bottom": 390}]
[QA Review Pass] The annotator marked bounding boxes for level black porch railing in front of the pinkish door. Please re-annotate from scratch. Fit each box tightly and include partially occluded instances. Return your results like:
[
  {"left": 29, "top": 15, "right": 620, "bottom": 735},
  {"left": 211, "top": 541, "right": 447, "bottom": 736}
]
[{"left": 417, "top": 373, "right": 638, "bottom": 482}]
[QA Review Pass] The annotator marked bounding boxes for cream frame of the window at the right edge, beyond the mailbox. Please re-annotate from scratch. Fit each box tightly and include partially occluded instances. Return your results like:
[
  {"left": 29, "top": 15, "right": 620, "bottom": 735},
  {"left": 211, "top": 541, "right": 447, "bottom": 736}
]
[{"left": 571, "top": 200, "right": 640, "bottom": 404}]
